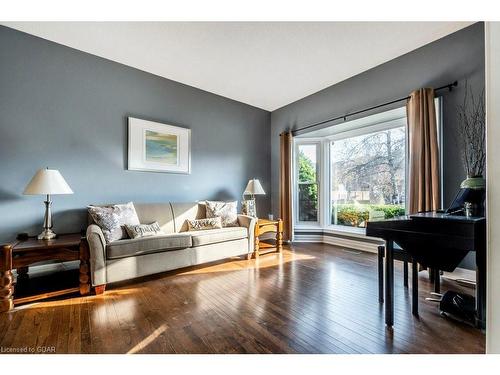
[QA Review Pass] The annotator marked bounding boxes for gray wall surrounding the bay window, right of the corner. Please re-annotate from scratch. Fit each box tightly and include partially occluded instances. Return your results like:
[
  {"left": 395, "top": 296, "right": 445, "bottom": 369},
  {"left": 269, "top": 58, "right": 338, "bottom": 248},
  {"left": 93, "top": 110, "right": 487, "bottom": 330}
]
[{"left": 271, "top": 23, "right": 485, "bottom": 265}]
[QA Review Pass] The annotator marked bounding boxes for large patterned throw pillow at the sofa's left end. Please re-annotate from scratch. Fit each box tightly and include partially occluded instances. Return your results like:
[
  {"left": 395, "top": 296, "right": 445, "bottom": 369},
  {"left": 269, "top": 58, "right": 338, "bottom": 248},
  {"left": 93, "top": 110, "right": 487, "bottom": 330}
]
[{"left": 87, "top": 202, "right": 140, "bottom": 243}]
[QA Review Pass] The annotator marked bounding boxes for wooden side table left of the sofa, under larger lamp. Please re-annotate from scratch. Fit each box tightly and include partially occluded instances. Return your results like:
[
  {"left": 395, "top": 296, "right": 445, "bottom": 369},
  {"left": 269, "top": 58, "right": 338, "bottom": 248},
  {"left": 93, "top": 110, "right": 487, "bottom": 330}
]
[{"left": 0, "top": 234, "right": 90, "bottom": 312}]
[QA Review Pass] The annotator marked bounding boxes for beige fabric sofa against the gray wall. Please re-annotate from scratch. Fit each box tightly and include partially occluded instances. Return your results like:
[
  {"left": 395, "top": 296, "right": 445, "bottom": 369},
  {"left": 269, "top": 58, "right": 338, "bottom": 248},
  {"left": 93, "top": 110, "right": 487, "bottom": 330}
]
[{"left": 87, "top": 202, "right": 256, "bottom": 293}]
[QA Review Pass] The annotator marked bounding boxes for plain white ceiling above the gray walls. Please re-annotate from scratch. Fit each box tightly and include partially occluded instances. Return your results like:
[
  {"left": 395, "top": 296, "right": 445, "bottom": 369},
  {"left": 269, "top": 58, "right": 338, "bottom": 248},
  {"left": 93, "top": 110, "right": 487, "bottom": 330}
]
[{"left": 3, "top": 22, "right": 471, "bottom": 111}]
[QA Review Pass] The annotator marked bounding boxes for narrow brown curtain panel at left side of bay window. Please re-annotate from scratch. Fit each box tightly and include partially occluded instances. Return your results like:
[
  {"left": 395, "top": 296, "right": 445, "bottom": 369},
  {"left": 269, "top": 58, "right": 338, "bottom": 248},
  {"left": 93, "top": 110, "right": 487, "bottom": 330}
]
[{"left": 280, "top": 132, "right": 293, "bottom": 241}]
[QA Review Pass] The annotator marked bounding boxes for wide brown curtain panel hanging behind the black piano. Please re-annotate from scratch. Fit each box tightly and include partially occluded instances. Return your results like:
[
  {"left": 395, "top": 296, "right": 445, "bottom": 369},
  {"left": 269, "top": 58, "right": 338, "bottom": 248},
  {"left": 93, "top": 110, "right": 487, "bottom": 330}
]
[{"left": 406, "top": 88, "right": 441, "bottom": 214}]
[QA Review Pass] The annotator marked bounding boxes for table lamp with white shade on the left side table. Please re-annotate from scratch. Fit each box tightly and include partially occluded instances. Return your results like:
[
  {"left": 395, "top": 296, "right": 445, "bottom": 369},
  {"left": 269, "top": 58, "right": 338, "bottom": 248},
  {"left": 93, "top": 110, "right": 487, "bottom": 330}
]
[{"left": 24, "top": 167, "right": 73, "bottom": 240}]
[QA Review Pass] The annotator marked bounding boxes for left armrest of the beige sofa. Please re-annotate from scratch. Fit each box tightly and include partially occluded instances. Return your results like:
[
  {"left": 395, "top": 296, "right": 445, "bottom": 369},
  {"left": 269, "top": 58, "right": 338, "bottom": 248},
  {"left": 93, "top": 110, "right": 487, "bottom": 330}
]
[{"left": 87, "top": 224, "right": 106, "bottom": 286}]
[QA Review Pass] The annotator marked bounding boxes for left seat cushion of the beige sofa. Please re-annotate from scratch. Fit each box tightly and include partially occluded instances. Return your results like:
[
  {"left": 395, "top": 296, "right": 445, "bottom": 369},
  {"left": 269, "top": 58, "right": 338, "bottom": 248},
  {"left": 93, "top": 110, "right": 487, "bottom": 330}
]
[{"left": 106, "top": 233, "right": 192, "bottom": 259}]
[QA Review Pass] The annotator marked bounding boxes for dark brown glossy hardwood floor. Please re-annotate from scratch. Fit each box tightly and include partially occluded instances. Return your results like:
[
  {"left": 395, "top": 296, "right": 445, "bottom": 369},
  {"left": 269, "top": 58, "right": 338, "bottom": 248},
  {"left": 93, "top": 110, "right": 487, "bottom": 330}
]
[{"left": 0, "top": 243, "right": 485, "bottom": 353}]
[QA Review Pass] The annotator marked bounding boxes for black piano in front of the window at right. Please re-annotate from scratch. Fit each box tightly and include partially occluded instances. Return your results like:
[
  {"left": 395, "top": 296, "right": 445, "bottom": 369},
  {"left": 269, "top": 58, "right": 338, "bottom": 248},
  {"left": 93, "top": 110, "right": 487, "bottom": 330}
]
[{"left": 366, "top": 189, "right": 486, "bottom": 329}]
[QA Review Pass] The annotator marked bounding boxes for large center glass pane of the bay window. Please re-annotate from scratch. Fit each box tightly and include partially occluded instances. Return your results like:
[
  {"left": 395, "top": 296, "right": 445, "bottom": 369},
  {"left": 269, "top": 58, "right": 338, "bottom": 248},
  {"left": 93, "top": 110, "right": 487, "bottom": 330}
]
[{"left": 330, "top": 127, "right": 406, "bottom": 227}]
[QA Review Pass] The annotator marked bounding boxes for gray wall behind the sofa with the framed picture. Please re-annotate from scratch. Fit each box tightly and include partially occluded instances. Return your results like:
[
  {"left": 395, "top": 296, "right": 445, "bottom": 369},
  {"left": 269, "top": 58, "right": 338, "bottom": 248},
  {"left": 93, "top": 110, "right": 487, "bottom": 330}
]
[{"left": 0, "top": 26, "right": 271, "bottom": 242}]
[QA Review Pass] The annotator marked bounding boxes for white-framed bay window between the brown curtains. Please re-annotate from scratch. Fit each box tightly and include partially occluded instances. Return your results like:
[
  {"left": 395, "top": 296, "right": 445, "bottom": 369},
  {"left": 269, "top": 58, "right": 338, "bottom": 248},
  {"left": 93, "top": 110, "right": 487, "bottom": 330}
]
[{"left": 294, "top": 98, "right": 442, "bottom": 233}]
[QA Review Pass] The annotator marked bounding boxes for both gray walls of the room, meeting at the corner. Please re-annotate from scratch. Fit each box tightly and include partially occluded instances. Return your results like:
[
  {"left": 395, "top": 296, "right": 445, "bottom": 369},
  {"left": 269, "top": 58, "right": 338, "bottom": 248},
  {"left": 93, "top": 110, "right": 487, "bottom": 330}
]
[{"left": 0, "top": 23, "right": 485, "bottom": 270}]
